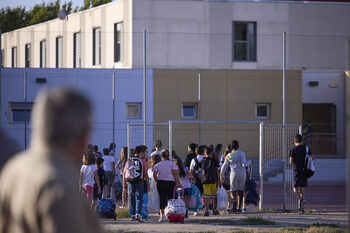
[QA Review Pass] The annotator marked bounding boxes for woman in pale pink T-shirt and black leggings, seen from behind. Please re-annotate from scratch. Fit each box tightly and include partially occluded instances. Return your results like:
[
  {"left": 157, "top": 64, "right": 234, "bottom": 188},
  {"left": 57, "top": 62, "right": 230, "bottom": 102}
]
[{"left": 152, "top": 149, "right": 181, "bottom": 222}]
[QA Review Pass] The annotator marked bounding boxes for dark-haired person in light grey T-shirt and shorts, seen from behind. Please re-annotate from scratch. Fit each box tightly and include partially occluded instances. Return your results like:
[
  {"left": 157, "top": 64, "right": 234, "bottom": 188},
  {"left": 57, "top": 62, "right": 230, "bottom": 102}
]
[{"left": 220, "top": 140, "right": 251, "bottom": 213}]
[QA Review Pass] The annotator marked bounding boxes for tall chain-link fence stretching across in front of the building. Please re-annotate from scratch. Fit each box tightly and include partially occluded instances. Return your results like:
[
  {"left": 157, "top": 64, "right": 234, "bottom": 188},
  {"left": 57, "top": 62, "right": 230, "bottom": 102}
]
[{"left": 0, "top": 27, "right": 349, "bottom": 211}]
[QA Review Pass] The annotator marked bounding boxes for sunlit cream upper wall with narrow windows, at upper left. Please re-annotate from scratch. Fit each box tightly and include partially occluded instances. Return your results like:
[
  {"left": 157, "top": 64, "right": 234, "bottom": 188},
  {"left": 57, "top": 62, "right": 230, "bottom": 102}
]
[{"left": 2, "top": 0, "right": 132, "bottom": 68}]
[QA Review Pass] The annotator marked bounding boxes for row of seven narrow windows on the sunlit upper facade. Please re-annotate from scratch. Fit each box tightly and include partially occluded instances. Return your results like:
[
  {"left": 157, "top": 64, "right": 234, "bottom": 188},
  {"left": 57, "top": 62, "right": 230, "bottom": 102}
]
[{"left": 11, "top": 23, "right": 122, "bottom": 68}]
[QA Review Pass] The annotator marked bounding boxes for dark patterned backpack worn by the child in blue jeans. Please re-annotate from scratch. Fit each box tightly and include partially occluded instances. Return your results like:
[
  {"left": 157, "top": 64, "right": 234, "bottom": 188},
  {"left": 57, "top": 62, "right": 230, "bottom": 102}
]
[{"left": 125, "top": 157, "right": 143, "bottom": 184}]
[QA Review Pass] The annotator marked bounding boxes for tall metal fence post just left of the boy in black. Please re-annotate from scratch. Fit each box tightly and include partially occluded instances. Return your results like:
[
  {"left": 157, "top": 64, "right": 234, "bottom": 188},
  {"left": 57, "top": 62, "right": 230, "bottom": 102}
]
[{"left": 282, "top": 32, "right": 287, "bottom": 209}]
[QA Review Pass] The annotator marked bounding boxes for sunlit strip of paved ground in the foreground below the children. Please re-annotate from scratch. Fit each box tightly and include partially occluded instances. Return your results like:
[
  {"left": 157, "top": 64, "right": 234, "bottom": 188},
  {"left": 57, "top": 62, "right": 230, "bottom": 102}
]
[{"left": 101, "top": 212, "right": 348, "bottom": 233}]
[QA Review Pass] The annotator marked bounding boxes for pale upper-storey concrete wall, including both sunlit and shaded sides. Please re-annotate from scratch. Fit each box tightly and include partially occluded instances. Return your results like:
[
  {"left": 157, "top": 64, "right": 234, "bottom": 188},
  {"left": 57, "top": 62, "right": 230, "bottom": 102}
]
[{"left": 2, "top": 0, "right": 350, "bottom": 72}]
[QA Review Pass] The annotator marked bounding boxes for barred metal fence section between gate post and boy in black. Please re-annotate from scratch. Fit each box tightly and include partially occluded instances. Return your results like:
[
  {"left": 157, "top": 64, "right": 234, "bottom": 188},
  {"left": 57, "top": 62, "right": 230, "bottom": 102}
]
[{"left": 263, "top": 124, "right": 301, "bottom": 209}]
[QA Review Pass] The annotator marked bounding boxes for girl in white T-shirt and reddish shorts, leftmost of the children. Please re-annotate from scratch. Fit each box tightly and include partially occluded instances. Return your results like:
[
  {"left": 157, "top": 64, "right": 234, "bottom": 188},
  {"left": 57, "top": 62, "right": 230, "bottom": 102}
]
[{"left": 79, "top": 152, "right": 101, "bottom": 208}]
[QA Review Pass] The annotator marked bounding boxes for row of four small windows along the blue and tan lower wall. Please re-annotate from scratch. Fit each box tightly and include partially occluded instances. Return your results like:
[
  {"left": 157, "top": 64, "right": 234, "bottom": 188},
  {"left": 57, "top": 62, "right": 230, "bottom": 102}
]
[{"left": 9, "top": 102, "right": 270, "bottom": 122}]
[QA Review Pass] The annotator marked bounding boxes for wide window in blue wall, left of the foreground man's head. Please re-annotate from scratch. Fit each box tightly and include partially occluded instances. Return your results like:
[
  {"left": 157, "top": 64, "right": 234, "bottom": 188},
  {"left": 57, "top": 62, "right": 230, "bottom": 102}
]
[{"left": 9, "top": 102, "right": 33, "bottom": 122}]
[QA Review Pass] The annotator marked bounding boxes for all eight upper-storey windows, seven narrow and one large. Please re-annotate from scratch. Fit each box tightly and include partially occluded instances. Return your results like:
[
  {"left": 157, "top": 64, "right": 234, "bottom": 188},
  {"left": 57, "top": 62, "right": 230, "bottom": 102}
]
[{"left": 6, "top": 21, "right": 256, "bottom": 68}]
